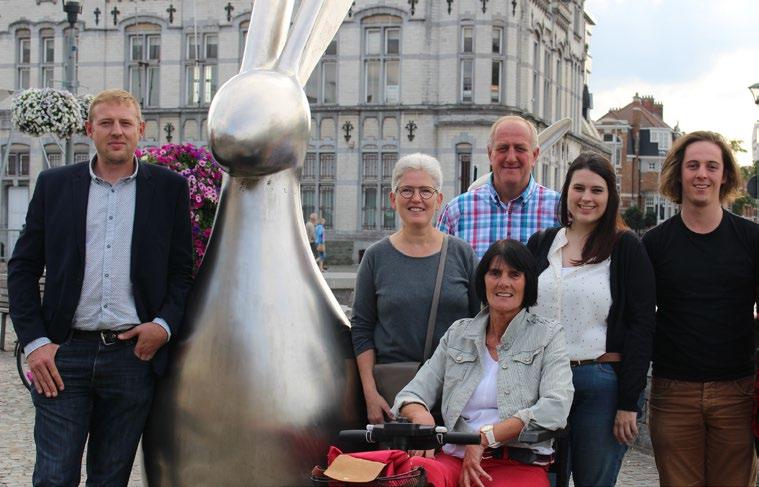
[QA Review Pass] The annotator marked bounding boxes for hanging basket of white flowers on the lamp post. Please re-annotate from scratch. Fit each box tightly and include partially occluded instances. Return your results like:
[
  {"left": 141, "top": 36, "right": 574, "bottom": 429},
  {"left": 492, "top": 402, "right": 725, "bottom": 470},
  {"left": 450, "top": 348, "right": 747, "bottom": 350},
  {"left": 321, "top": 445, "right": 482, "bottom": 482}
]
[{"left": 11, "top": 88, "right": 83, "bottom": 139}]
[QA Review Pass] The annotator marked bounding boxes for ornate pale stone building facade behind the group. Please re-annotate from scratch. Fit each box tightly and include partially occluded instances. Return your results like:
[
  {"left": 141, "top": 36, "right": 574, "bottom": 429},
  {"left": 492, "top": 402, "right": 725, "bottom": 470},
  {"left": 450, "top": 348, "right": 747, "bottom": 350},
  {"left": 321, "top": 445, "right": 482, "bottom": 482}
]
[{"left": 0, "top": 0, "right": 608, "bottom": 260}]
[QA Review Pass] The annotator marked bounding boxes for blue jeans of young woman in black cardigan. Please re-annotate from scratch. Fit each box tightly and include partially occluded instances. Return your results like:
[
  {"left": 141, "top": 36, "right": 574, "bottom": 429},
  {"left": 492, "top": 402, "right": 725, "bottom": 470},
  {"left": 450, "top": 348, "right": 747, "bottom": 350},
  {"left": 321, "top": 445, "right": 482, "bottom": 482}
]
[{"left": 567, "top": 364, "right": 627, "bottom": 487}]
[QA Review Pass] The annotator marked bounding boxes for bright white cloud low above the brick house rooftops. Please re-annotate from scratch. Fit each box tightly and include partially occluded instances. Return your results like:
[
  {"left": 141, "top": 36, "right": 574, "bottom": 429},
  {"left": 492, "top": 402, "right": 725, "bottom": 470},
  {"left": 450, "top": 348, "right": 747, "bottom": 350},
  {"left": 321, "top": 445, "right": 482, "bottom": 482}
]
[{"left": 591, "top": 48, "right": 759, "bottom": 164}]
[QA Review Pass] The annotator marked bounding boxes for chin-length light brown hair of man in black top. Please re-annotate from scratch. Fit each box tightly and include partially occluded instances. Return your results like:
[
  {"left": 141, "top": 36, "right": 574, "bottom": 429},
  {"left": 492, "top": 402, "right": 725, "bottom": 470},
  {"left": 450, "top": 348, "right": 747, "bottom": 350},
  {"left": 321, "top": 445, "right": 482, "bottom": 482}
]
[{"left": 659, "top": 130, "right": 741, "bottom": 205}]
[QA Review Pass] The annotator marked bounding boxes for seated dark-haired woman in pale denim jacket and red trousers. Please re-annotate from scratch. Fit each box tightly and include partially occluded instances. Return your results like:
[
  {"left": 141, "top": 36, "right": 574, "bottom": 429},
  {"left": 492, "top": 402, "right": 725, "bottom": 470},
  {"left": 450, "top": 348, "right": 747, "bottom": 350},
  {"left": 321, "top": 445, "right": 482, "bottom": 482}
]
[{"left": 393, "top": 240, "right": 574, "bottom": 487}]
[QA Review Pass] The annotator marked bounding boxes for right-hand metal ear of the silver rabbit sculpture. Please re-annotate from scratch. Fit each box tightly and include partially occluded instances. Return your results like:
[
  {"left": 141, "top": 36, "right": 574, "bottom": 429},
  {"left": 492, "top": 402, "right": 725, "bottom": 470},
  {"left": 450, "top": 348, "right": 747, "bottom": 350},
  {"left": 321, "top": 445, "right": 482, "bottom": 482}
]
[{"left": 277, "top": 0, "right": 353, "bottom": 86}]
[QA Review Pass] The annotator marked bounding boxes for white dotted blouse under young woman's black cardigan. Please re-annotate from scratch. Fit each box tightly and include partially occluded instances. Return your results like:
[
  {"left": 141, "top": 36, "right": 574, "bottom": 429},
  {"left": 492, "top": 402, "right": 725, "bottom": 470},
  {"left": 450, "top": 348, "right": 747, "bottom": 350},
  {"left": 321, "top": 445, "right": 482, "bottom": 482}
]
[{"left": 530, "top": 228, "right": 611, "bottom": 360}]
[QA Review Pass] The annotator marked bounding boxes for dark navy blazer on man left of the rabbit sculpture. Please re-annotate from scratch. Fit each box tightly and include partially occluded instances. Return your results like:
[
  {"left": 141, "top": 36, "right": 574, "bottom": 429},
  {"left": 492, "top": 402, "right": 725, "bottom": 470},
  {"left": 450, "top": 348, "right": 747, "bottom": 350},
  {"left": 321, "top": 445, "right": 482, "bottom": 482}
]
[{"left": 8, "top": 162, "right": 193, "bottom": 374}]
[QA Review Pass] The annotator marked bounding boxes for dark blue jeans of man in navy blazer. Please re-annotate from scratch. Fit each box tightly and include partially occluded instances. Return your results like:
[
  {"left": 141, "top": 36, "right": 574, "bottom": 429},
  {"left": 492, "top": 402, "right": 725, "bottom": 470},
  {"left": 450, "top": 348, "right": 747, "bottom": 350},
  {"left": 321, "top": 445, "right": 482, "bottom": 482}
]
[{"left": 32, "top": 339, "right": 154, "bottom": 486}]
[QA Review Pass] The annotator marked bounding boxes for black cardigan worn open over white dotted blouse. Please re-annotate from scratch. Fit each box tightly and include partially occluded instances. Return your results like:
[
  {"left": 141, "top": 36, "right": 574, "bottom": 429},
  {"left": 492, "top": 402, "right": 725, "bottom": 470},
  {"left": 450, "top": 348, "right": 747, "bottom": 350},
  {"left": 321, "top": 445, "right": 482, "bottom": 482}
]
[{"left": 527, "top": 228, "right": 656, "bottom": 413}]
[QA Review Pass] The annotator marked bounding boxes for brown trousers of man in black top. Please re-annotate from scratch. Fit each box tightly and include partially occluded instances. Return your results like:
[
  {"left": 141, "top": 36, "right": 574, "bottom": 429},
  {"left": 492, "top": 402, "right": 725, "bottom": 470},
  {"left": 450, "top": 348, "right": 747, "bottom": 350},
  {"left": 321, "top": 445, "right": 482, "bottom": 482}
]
[{"left": 650, "top": 377, "right": 757, "bottom": 487}]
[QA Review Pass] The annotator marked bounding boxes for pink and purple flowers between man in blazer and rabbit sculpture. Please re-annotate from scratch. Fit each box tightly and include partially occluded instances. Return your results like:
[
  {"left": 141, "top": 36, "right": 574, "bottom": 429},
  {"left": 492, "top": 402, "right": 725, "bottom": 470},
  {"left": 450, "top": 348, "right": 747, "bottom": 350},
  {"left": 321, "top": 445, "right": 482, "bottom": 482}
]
[{"left": 137, "top": 144, "right": 222, "bottom": 272}]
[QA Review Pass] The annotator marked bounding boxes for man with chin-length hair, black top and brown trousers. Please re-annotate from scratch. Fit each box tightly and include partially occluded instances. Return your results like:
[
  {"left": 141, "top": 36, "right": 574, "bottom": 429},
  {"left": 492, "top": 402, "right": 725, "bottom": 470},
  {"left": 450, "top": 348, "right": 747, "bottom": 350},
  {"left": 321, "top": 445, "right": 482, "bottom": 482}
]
[{"left": 643, "top": 132, "right": 759, "bottom": 487}]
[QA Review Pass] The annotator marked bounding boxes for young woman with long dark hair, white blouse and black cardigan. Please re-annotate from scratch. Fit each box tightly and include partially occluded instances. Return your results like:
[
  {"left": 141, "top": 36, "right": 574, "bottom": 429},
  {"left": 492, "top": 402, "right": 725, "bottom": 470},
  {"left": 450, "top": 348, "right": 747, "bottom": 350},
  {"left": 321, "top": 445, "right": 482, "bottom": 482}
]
[{"left": 528, "top": 152, "right": 655, "bottom": 487}]
